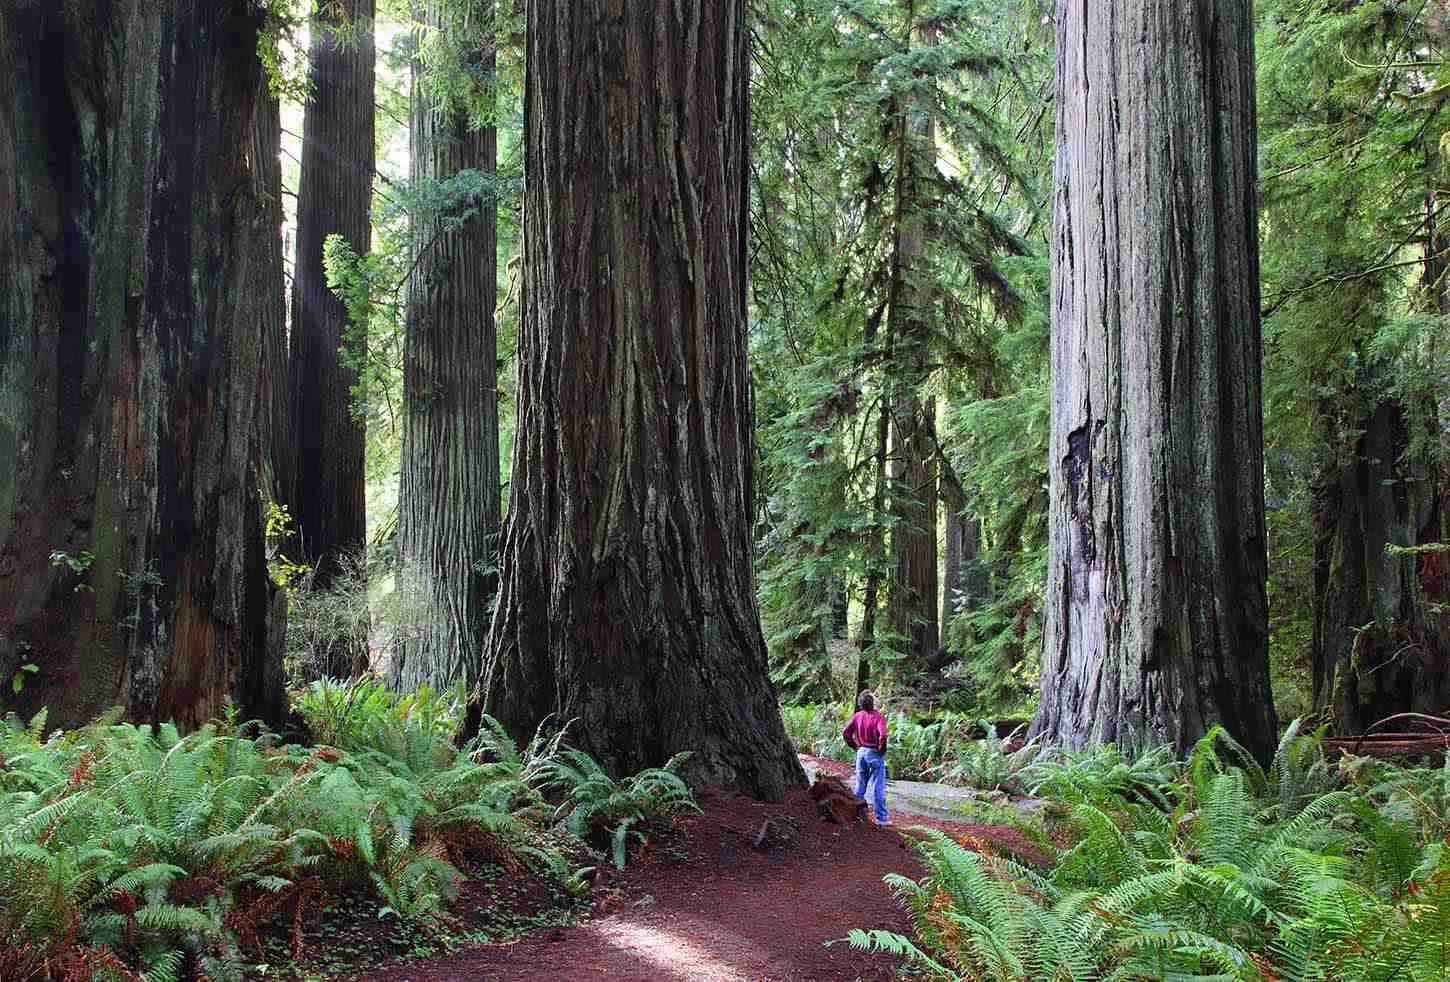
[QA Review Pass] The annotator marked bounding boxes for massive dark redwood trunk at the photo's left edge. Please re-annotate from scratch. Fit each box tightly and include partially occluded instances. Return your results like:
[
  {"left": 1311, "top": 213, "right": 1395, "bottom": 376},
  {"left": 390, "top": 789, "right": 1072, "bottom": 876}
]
[{"left": 0, "top": 0, "right": 283, "bottom": 725}]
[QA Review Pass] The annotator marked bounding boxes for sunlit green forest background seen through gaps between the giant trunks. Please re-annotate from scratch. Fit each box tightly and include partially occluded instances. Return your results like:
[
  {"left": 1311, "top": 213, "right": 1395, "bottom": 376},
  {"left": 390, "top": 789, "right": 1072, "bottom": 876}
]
[{"left": 303, "top": 0, "right": 1450, "bottom": 725}]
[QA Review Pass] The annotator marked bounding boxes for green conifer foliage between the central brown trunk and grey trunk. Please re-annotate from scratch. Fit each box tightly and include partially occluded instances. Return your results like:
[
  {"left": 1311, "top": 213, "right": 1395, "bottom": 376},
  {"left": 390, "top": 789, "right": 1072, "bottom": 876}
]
[{"left": 750, "top": 0, "right": 1051, "bottom": 708}]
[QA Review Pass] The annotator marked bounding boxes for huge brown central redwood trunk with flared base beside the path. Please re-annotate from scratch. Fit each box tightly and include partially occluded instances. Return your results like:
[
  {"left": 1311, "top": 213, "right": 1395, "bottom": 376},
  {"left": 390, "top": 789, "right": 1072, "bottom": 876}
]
[{"left": 458, "top": 0, "right": 802, "bottom": 798}]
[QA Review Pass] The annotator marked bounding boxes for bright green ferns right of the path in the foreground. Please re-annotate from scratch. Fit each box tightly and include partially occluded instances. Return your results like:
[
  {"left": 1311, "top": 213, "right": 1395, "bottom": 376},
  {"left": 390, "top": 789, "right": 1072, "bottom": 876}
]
[{"left": 848, "top": 724, "right": 1450, "bottom": 982}]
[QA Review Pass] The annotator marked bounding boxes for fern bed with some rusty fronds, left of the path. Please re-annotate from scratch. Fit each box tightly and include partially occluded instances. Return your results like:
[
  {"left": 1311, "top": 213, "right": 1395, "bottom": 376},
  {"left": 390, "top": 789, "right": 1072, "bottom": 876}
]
[{"left": 0, "top": 682, "right": 690, "bottom": 982}]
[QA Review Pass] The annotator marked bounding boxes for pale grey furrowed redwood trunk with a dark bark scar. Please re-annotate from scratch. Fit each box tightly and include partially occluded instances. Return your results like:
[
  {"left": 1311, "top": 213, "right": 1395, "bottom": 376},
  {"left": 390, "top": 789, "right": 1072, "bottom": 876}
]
[{"left": 1032, "top": 0, "right": 1276, "bottom": 757}]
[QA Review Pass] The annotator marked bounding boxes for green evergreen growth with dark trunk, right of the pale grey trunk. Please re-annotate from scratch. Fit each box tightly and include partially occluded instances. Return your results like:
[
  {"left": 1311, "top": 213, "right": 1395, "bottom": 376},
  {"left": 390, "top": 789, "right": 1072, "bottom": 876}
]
[{"left": 1259, "top": 0, "right": 1450, "bottom": 733}]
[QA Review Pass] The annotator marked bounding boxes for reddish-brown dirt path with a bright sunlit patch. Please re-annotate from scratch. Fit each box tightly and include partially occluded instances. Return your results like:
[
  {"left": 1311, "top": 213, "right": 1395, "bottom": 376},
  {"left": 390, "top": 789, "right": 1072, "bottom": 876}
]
[{"left": 264, "top": 760, "right": 1025, "bottom": 982}]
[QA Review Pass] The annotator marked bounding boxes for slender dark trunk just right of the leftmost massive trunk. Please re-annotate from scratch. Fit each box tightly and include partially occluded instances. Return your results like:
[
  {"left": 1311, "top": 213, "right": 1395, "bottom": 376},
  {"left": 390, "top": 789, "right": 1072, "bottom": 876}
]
[{"left": 289, "top": 0, "right": 376, "bottom": 677}]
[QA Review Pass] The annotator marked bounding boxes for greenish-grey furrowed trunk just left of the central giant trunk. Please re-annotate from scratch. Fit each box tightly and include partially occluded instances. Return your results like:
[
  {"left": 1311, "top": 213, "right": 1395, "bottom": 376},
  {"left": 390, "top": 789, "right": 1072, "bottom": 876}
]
[{"left": 394, "top": 1, "right": 500, "bottom": 689}]
